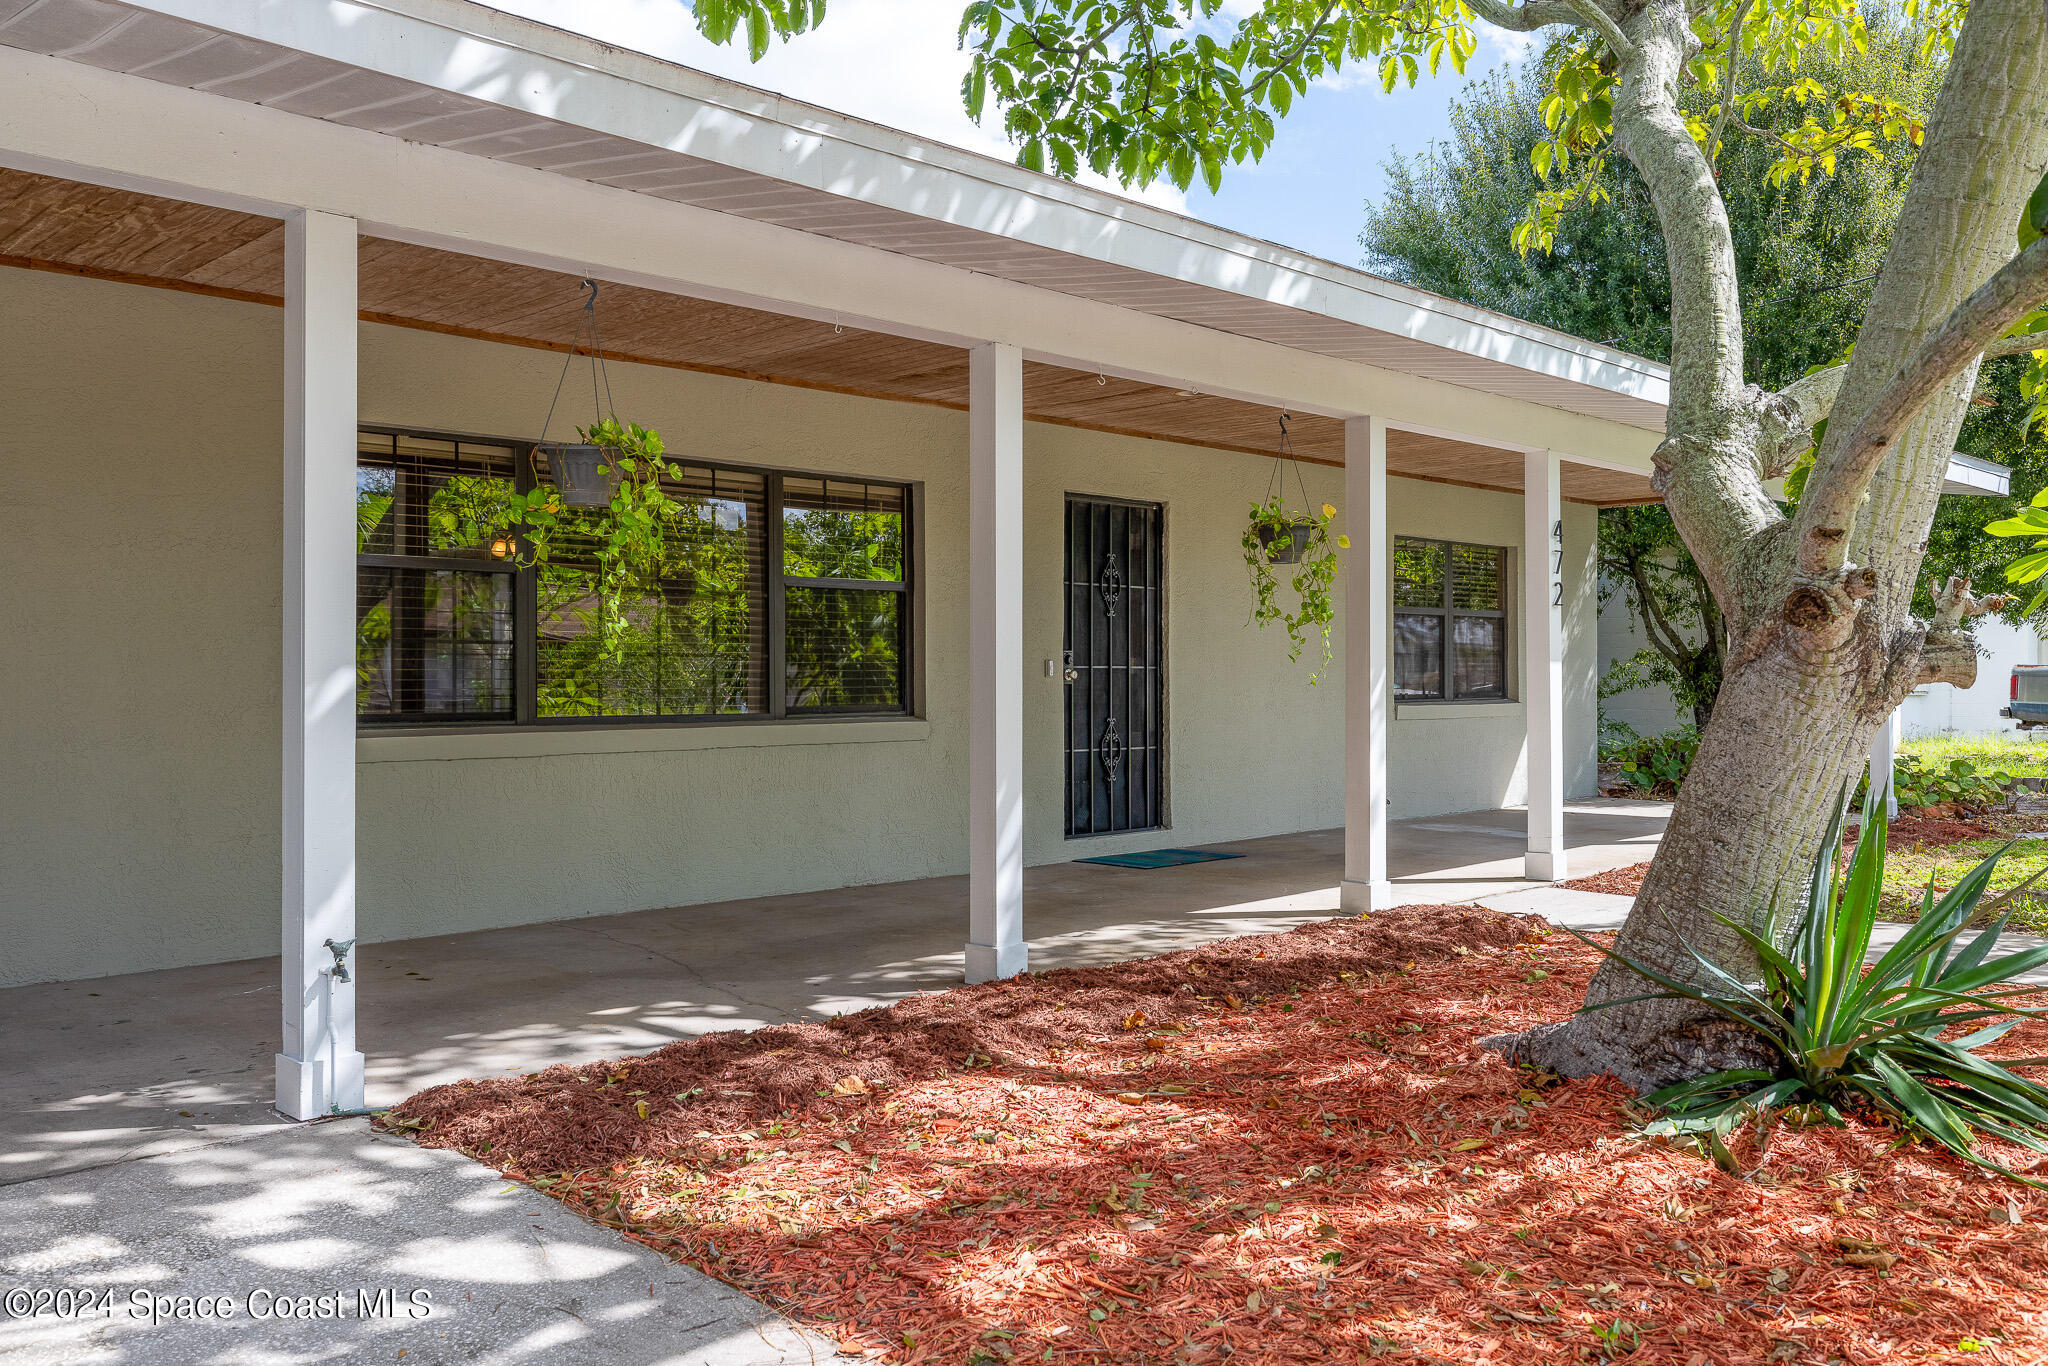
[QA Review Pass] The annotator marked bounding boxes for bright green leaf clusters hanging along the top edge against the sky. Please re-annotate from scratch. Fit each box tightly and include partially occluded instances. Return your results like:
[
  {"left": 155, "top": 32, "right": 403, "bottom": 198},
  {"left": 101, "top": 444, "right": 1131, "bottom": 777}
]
[{"left": 694, "top": 0, "right": 1933, "bottom": 272}]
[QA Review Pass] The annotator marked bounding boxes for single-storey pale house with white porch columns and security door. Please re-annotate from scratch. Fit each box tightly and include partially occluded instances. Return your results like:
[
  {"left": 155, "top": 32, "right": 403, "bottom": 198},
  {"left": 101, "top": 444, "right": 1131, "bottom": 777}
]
[{"left": 0, "top": 0, "right": 1667, "bottom": 1116}]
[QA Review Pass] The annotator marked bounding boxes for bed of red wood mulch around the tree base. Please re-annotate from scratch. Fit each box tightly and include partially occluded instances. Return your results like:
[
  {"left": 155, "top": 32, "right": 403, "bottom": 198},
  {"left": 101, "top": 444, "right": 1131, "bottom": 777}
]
[{"left": 380, "top": 907, "right": 2048, "bottom": 1366}]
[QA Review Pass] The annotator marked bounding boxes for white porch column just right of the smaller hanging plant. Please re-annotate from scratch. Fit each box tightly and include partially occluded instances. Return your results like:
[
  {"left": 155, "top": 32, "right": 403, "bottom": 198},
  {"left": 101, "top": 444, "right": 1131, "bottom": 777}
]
[{"left": 1337, "top": 418, "right": 1395, "bottom": 915}]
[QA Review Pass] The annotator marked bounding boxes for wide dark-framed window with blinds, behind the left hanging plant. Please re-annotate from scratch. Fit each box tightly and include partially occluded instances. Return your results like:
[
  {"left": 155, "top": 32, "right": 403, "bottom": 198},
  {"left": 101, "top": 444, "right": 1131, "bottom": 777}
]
[{"left": 356, "top": 430, "right": 915, "bottom": 725}]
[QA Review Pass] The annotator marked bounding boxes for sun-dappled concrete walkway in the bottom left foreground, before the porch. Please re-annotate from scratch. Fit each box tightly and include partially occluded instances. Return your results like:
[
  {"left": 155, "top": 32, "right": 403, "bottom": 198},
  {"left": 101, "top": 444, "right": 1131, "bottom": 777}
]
[{"left": 0, "top": 1120, "right": 852, "bottom": 1366}]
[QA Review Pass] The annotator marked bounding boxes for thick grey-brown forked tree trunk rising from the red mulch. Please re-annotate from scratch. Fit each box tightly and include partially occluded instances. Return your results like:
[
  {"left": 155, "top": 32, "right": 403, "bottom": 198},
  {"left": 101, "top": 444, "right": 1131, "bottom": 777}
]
[{"left": 1495, "top": 0, "right": 2048, "bottom": 1090}]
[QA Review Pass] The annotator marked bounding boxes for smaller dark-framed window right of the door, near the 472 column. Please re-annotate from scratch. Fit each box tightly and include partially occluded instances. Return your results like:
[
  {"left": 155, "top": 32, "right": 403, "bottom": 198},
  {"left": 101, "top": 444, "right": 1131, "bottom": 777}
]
[{"left": 1393, "top": 537, "right": 1509, "bottom": 702}]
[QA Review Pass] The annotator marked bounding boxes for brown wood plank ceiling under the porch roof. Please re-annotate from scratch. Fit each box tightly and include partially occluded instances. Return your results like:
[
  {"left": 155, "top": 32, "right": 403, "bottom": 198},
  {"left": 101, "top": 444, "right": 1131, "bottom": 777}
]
[{"left": 0, "top": 168, "right": 1655, "bottom": 506}]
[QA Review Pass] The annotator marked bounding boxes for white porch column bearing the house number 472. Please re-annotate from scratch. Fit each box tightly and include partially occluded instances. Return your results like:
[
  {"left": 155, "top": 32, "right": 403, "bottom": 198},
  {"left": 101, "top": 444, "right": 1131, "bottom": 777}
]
[{"left": 1522, "top": 451, "right": 1571, "bottom": 883}]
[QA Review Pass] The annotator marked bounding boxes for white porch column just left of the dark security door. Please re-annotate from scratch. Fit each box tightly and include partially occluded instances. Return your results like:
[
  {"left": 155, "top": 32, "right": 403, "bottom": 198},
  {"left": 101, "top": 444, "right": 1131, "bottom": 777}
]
[{"left": 967, "top": 344, "right": 1024, "bottom": 981}]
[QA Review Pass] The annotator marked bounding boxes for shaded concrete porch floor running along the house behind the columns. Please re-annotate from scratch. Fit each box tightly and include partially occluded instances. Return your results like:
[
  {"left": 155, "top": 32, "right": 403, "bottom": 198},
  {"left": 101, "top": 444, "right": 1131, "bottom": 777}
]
[{"left": 0, "top": 799, "right": 1669, "bottom": 1186}]
